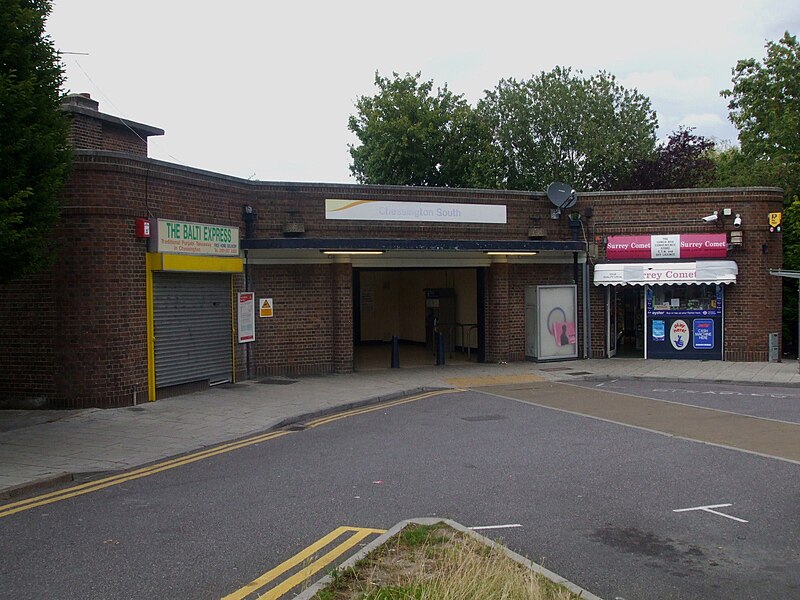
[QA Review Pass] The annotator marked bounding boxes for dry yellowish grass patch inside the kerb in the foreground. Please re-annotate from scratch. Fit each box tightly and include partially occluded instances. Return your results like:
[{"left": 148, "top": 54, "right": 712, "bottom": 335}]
[{"left": 314, "top": 523, "right": 579, "bottom": 600}]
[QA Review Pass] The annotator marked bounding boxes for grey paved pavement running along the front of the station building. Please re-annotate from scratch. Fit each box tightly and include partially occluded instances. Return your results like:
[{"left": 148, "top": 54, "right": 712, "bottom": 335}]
[{"left": 0, "top": 358, "right": 800, "bottom": 502}]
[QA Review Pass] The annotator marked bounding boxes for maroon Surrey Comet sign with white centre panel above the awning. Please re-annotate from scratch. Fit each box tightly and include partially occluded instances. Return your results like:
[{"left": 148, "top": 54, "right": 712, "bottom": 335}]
[{"left": 606, "top": 233, "right": 728, "bottom": 260}]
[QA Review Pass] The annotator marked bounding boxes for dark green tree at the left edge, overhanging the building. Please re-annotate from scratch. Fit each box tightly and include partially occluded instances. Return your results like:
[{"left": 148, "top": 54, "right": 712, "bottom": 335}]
[{"left": 0, "top": 0, "right": 70, "bottom": 283}]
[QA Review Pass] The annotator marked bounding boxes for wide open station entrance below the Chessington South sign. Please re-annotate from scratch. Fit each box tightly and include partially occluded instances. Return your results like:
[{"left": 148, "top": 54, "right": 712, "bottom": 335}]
[{"left": 353, "top": 267, "right": 485, "bottom": 370}]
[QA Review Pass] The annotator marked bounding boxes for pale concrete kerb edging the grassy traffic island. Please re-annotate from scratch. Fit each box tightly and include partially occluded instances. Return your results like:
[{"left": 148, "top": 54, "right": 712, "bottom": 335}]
[{"left": 295, "top": 517, "right": 602, "bottom": 600}]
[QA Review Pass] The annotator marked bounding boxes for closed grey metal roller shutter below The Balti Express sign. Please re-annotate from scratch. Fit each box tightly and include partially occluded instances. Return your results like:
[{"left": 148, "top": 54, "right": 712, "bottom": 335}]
[{"left": 153, "top": 272, "right": 233, "bottom": 387}]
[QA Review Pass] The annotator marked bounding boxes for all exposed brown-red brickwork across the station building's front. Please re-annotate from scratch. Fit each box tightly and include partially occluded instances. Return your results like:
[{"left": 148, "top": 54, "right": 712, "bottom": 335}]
[{"left": 0, "top": 142, "right": 782, "bottom": 407}]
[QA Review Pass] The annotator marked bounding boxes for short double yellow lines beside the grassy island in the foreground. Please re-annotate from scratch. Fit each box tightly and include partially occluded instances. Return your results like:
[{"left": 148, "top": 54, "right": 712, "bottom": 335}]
[{"left": 222, "top": 527, "right": 385, "bottom": 600}]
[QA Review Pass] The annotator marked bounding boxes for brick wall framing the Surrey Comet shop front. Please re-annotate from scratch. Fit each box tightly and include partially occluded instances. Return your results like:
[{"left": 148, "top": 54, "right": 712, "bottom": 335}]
[{"left": 582, "top": 188, "right": 783, "bottom": 361}]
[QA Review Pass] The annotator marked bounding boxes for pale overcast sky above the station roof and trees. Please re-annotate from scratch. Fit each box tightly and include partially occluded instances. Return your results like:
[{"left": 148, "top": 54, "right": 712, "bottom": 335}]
[{"left": 47, "top": 0, "right": 800, "bottom": 182}]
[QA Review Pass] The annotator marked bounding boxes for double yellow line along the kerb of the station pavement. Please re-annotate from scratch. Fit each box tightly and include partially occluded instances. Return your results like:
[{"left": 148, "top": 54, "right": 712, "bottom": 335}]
[{"left": 0, "top": 390, "right": 460, "bottom": 518}]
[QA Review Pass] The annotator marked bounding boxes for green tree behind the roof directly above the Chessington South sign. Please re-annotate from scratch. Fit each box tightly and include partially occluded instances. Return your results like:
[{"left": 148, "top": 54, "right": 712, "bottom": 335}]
[{"left": 348, "top": 73, "right": 485, "bottom": 187}]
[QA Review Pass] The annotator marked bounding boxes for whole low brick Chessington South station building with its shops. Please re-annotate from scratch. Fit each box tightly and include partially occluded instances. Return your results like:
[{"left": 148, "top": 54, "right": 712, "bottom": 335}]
[{"left": 0, "top": 96, "right": 782, "bottom": 408}]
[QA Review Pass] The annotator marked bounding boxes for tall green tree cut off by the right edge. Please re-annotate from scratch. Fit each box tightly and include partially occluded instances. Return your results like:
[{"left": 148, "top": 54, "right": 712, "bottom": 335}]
[{"left": 722, "top": 31, "right": 800, "bottom": 199}]
